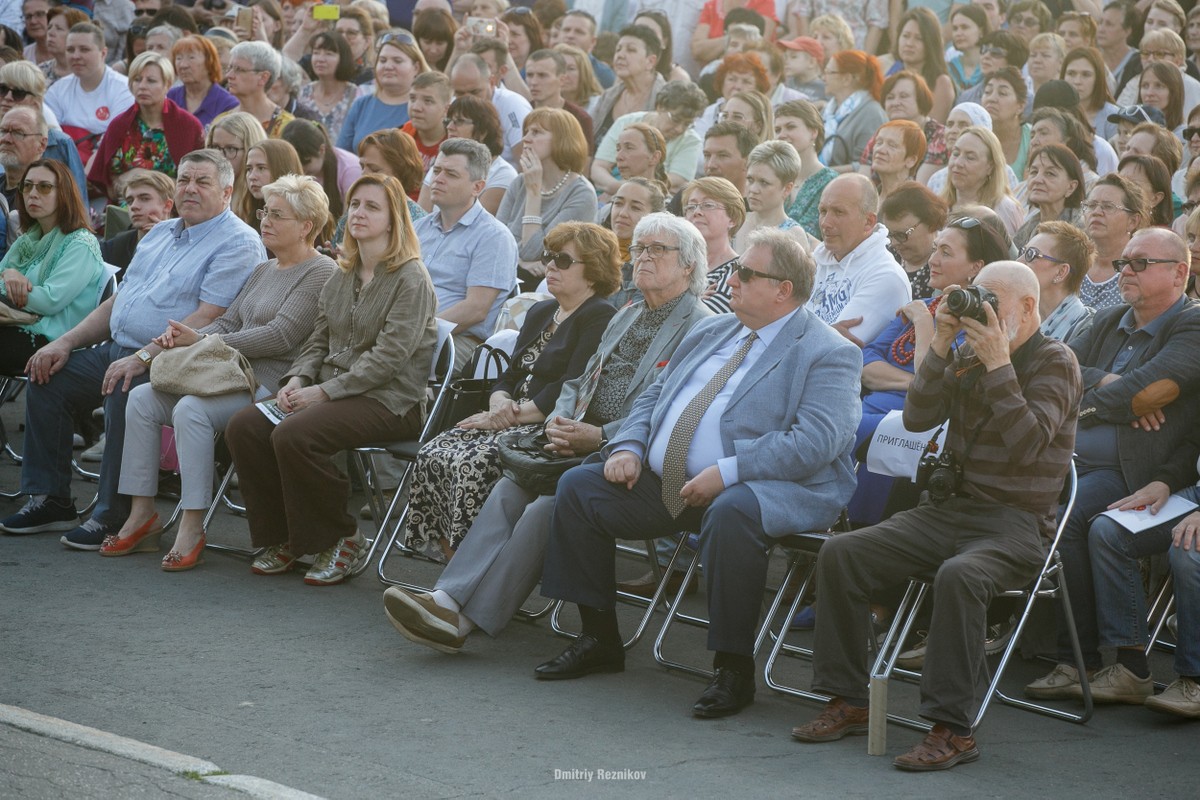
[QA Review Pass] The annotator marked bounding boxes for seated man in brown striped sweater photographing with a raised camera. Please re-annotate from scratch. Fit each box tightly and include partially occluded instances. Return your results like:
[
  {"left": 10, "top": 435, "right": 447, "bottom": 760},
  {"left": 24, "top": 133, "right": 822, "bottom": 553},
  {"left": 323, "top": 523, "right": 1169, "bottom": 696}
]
[{"left": 792, "top": 261, "right": 1082, "bottom": 771}]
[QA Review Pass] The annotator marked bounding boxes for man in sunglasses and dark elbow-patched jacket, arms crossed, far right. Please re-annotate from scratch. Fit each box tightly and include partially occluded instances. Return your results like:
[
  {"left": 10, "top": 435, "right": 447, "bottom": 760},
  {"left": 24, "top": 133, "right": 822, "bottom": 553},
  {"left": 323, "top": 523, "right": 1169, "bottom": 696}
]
[{"left": 1025, "top": 228, "right": 1200, "bottom": 704}]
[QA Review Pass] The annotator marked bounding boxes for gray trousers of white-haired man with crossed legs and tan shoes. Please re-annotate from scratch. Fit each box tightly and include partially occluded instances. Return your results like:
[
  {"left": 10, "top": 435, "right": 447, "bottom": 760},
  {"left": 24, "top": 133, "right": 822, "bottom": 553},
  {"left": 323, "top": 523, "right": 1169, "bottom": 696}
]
[{"left": 434, "top": 477, "right": 554, "bottom": 636}]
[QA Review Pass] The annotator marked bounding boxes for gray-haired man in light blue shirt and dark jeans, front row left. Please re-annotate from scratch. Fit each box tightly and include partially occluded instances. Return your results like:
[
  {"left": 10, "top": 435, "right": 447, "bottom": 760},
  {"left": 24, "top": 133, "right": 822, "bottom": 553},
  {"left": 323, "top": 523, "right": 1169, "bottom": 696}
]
[{"left": 0, "top": 150, "right": 266, "bottom": 551}]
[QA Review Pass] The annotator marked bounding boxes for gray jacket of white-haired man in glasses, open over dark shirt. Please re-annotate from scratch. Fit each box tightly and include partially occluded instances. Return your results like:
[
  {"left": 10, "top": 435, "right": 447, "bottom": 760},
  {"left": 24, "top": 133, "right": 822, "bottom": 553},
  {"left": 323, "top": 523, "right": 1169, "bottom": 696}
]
[{"left": 546, "top": 293, "right": 713, "bottom": 439}]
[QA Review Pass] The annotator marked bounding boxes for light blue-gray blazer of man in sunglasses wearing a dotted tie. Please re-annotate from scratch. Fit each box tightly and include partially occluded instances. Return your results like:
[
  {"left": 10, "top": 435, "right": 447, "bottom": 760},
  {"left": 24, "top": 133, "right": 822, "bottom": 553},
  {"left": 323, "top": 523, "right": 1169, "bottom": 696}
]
[{"left": 605, "top": 308, "right": 863, "bottom": 536}]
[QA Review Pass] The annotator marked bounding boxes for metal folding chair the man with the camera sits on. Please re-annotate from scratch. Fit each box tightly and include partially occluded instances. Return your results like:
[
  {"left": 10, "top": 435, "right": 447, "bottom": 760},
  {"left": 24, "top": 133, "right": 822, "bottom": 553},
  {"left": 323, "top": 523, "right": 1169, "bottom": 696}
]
[{"left": 871, "top": 462, "right": 1092, "bottom": 730}]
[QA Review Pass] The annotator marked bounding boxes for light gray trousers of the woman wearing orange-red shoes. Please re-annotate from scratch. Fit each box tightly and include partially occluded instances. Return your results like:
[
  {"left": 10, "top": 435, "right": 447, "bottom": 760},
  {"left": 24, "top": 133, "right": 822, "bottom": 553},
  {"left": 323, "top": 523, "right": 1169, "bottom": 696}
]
[{"left": 118, "top": 384, "right": 251, "bottom": 511}]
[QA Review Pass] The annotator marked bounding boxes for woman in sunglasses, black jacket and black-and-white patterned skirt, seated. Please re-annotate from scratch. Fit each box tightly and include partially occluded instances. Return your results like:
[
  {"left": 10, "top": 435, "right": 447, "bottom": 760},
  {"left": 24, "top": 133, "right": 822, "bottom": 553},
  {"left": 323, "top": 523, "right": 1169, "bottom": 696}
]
[{"left": 406, "top": 221, "right": 620, "bottom": 561}]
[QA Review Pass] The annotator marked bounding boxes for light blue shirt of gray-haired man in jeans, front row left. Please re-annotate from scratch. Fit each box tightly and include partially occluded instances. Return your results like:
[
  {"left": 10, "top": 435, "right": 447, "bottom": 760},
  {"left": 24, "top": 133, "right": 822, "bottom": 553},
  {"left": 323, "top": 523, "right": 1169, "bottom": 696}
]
[{"left": 109, "top": 209, "right": 266, "bottom": 348}]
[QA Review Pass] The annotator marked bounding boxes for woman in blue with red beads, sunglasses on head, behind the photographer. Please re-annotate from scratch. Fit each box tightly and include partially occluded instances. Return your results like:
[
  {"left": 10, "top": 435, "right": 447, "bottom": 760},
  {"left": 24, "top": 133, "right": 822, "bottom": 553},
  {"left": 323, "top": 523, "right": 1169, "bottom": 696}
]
[{"left": 848, "top": 207, "right": 1009, "bottom": 524}]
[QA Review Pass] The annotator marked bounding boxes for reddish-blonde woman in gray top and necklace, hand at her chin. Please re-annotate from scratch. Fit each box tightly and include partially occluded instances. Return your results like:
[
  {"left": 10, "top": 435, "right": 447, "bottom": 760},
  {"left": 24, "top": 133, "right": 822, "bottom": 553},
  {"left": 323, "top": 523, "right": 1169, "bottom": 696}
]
[{"left": 496, "top": 108, "right": 596, "bottom": 289}]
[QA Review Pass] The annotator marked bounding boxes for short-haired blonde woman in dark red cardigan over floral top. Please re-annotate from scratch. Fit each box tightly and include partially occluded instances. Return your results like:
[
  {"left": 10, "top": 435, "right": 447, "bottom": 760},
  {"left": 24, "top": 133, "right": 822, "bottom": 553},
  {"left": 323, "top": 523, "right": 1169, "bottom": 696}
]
[{"left": 88, "top": 50, "right": 204, "bottom": 199}]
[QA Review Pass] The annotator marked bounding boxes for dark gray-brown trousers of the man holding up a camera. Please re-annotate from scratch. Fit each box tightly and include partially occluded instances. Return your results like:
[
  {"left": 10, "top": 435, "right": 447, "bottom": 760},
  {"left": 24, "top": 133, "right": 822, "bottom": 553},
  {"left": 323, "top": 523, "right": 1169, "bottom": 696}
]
[{"left": 812, "top": 498, "right": 1045, "bottom": 727}]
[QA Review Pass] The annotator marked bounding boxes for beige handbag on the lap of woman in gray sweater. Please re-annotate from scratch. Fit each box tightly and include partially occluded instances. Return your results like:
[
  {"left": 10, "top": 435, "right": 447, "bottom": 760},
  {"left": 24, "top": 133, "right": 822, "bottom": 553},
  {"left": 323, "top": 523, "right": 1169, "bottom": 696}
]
[{"left": 150, "top": 336, "right": 258, "bottom": 397}]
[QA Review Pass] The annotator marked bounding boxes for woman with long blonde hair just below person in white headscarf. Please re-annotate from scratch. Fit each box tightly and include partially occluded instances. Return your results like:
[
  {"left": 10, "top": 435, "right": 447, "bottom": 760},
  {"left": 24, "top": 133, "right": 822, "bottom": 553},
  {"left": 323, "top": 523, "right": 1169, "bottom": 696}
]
[{"left": 942, "top": 125, "right": 1025, "bottom": 236}]
